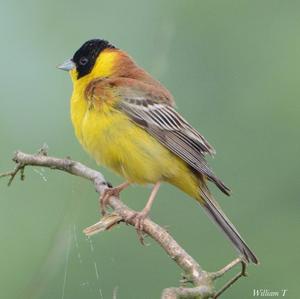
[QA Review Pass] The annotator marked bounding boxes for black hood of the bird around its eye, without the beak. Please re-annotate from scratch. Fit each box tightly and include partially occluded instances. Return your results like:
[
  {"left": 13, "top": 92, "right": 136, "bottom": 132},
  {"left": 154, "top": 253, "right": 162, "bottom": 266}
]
[{"left": 72, "top": 39, "right": 115, "bottom": 79}]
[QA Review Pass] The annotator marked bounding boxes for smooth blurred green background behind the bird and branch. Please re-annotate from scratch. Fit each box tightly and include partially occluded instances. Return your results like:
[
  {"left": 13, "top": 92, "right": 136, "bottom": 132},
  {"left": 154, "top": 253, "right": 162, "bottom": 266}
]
[{"left": 0, "top": 0, "right": 300, "bottom": 299}]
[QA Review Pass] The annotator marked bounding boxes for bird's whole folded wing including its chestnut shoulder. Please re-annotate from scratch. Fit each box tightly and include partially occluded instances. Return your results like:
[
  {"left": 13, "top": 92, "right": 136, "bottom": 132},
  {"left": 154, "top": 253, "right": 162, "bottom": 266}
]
[{"left": 90, "top": 78, "right": 230, "bottom": 195}]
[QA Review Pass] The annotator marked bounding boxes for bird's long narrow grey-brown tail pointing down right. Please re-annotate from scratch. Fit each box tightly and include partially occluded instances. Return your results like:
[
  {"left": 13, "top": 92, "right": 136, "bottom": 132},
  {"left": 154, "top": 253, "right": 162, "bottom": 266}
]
[{"left": 201, "top": 187, "right": 259, "bottom": 264}]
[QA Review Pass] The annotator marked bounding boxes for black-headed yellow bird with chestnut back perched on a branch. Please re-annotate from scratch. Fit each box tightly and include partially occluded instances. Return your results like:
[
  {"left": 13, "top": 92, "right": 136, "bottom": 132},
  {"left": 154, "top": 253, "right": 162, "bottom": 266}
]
[{"left": 58, "top": 39, "right": 258, "bottom": 264}]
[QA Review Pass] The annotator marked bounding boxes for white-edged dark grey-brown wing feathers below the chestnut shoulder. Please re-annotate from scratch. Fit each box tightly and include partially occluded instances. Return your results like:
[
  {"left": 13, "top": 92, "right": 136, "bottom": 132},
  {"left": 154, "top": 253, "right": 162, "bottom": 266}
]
[{"left": 118, "top": 97, "right": 229, "bottom": 195}]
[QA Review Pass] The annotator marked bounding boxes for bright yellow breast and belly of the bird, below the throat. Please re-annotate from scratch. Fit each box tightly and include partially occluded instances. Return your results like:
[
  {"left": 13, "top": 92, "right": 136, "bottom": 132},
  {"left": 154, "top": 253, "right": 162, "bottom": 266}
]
[{"left": 71, "top": 95, "right": 199, "bottom": 197}]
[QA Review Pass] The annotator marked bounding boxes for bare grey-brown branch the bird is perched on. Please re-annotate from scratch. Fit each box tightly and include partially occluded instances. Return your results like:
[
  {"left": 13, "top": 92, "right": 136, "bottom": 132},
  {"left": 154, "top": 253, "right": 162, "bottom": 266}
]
[{"left": 0, "top": 148, "right": 250, "bottom": 299}]
